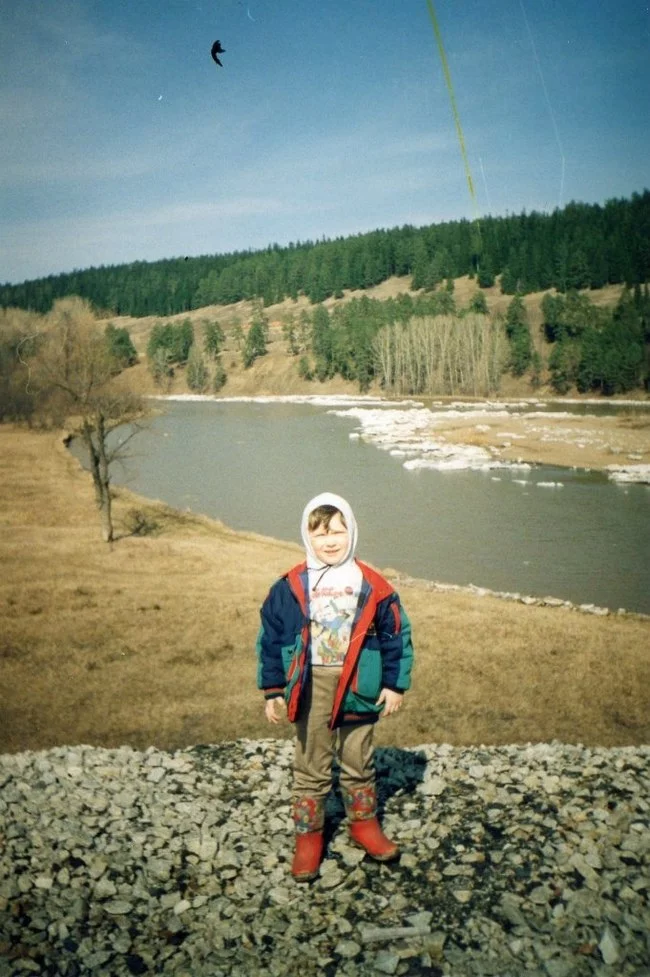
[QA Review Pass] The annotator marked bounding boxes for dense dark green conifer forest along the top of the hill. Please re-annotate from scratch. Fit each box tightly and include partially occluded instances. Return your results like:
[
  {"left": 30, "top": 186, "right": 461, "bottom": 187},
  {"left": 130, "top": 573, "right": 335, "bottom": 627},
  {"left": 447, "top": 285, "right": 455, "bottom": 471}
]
[{"left": 0, "top": 190, "right": 650, "bottom": 318}]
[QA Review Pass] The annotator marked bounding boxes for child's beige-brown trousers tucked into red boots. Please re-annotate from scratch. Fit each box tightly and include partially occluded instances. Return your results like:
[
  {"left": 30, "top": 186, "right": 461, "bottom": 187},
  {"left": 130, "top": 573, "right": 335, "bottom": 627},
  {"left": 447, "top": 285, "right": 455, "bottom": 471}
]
[{"left": 293, "top": 665, "right": 375, "bottom": 803}]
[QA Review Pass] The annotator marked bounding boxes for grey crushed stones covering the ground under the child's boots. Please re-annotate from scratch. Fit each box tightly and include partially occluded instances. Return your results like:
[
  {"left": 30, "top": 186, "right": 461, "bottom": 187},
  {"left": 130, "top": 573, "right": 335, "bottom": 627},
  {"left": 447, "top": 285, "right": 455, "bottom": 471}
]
[{"left": 0, "top": 740, "right": 650, "bottom": 977}]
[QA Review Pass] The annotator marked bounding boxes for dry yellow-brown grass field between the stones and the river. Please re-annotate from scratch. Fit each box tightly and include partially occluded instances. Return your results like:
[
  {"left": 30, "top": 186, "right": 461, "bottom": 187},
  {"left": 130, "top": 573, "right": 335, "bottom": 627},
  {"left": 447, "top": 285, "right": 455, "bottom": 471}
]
[{"left": 0, "top": 427, "right": 650, "bottom": 752}]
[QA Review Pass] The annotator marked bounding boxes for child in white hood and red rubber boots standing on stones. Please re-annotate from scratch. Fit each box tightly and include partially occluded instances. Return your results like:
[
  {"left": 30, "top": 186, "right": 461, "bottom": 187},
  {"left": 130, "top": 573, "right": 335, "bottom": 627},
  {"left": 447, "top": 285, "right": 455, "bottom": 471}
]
[{"left": 257, "top": 492, "right": 413, "bottom": 882}]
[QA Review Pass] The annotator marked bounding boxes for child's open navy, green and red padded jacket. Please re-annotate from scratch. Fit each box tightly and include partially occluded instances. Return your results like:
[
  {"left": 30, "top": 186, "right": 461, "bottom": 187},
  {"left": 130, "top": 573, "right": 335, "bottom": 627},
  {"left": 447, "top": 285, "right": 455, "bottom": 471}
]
[{"left": 257, "top": 560, "right": 413, "bottom": 729}]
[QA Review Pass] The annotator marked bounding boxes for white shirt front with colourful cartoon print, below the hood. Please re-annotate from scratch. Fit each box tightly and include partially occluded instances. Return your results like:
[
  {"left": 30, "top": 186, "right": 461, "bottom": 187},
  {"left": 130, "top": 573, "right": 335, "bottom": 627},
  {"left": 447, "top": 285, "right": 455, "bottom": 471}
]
[{"left": 309, "top": 561, "right": 362, "bottom": 665}]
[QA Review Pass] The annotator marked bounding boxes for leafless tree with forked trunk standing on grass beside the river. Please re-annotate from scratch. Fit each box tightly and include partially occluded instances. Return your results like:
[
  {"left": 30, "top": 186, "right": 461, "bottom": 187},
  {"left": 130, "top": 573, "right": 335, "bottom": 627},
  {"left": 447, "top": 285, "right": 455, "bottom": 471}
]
[{"left": 34, "top": 297, "right": 144, "bottom": 542}]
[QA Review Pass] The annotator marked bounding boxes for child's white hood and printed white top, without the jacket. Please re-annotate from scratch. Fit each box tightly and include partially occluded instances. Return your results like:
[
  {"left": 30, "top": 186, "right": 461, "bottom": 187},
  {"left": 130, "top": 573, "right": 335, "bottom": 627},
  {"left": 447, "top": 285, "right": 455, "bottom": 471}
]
[{"left": 300, "top": 492, "right": 362, "bottom": 665}]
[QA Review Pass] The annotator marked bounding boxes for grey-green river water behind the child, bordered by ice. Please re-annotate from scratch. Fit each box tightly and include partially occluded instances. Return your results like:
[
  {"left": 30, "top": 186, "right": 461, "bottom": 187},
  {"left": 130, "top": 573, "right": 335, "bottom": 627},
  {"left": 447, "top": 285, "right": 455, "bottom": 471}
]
[{"left": 92, "top": 401, "right": 650, "bottom": 613}]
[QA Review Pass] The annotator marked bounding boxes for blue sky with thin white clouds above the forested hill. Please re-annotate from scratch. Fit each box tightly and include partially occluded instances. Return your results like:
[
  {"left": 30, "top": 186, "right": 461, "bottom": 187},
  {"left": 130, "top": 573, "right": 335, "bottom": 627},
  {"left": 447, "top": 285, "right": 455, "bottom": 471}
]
[{"left": 0, "top": 0, "right": 650, "bottom": 282}]
